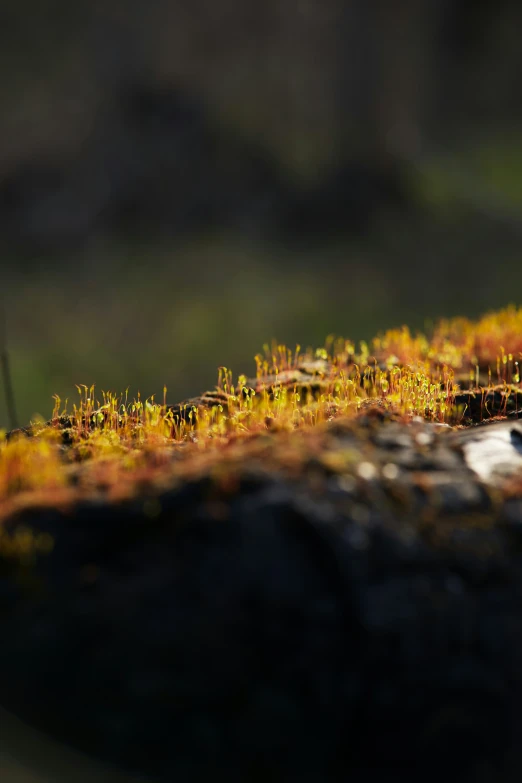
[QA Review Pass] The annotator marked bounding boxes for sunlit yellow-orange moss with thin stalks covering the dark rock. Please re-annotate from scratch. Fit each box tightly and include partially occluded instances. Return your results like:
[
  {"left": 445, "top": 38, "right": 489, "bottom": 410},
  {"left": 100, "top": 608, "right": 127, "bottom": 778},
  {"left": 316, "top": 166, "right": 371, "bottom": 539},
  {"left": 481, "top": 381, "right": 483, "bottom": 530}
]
[{"left": 0, "top": 306, "right": 522, "bottom": 532}]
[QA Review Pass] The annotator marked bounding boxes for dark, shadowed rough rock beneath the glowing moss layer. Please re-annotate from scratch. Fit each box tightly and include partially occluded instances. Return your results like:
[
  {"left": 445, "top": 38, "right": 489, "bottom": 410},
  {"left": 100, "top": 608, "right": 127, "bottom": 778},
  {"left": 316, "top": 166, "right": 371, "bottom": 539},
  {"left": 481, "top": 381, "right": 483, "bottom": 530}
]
[{"left": 0, "top": 414, "right": 522, "bottom": 783}]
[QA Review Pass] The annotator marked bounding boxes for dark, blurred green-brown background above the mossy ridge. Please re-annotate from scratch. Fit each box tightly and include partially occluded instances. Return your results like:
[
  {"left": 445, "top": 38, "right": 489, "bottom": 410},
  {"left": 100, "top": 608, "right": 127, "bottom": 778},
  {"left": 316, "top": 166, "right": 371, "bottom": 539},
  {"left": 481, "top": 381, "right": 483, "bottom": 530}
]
[{"left": 0, "top": 0, "right": 522, "bottom": 426}]
